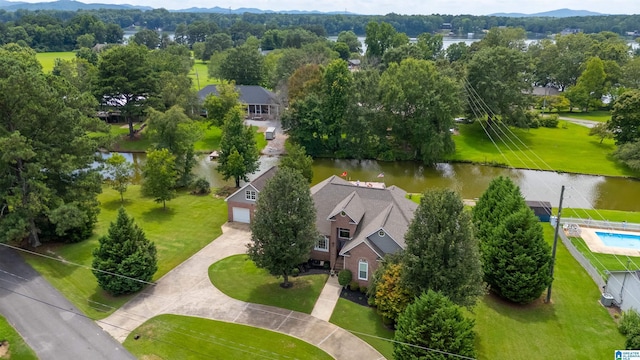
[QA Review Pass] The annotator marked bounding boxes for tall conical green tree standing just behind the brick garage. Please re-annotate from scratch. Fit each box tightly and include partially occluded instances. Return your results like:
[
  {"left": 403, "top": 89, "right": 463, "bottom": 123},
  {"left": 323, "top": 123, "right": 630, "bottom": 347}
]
[{"left": 217, "top": 107, "right": 260, "bottom": 187}]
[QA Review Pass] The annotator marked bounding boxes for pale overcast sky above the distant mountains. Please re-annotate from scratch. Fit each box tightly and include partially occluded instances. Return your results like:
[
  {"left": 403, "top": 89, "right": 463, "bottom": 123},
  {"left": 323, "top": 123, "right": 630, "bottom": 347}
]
[{"left": 10, "top": 0, "right": 640, "bottom": 15}]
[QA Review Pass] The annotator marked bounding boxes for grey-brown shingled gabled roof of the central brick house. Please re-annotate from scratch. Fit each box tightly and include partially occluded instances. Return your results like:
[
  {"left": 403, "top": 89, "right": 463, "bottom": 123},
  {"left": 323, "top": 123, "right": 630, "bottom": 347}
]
[{"left": 311, "top": 175, "right": 418, "bottom": 254}]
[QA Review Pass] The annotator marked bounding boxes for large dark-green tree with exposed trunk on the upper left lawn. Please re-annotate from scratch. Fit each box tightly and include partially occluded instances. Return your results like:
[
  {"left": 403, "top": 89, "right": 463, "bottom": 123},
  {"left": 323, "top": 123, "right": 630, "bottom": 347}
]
[{"left": 96, "top": 44, "right": 158, "bottom": 138}]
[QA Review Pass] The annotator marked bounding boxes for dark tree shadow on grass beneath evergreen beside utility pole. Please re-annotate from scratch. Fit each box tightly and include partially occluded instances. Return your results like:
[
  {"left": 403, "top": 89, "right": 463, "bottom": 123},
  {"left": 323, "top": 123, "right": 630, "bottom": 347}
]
[{"left": 482, "top": 292, "right": 557, "bottom": 323}]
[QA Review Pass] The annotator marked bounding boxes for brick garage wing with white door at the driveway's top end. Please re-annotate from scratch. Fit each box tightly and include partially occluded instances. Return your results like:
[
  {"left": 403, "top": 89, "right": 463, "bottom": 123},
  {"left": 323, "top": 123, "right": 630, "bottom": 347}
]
[{"left": 224, "top": 166, "right": 278, "bottom": 224}]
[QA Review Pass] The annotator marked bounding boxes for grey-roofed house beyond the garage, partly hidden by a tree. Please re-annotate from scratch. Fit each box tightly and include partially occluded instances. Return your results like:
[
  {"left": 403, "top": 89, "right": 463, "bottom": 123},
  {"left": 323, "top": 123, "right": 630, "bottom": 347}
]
[{"left": 198, "top": 85, "right": 280, "bottom": 119}]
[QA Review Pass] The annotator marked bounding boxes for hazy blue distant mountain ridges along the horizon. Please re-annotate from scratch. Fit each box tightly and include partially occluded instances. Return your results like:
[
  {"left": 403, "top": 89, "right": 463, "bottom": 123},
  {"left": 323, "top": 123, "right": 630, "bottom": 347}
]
[{"left": 0, "top": 0, "right": 606, "bottom": 18}]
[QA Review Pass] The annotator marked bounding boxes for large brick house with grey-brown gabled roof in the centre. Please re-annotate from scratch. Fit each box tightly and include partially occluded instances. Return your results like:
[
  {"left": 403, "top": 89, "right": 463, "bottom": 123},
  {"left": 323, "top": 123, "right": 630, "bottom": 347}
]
[{"left": 310, "top": 176, "right": 418, "bottom": 286}]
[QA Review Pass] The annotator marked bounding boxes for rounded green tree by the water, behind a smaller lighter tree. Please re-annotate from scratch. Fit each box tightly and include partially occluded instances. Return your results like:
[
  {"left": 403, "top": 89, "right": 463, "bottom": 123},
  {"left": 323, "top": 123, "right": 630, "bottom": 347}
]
[{"left": 147, "top": 106, "right": 202, "bottom": 187}]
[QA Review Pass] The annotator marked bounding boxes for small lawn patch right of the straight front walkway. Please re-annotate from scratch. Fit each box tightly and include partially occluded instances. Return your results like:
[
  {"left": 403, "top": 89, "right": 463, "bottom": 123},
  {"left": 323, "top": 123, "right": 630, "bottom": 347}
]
[{"left": 329, "top": 299, "right": 394, "bottom": 360}]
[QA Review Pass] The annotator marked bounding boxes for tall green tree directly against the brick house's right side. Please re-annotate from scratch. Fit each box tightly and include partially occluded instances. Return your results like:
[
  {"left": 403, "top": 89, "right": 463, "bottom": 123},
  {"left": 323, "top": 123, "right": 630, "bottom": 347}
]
[{"left": 402, "top": 189, "right": 484, "bottom": 306}]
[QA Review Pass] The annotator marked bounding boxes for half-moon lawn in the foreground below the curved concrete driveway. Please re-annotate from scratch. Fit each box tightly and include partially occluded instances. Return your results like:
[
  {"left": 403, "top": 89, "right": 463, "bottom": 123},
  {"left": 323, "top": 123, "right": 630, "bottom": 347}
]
[{"left": 124, "top": 315, "right": 332, "bottom": 360}]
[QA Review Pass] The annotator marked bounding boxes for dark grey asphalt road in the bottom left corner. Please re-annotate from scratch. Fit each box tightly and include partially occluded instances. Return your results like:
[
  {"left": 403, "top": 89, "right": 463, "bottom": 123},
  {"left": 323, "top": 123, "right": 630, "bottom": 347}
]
[{"left": 0, "top": 246, "right": 135, "bottom": 360}]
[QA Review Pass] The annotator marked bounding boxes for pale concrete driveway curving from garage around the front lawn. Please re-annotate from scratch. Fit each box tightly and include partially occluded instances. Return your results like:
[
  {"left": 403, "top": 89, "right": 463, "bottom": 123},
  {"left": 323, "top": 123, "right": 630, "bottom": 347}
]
[{"left": 101, "top": 223, "right": 384, "bottom": 360}]
